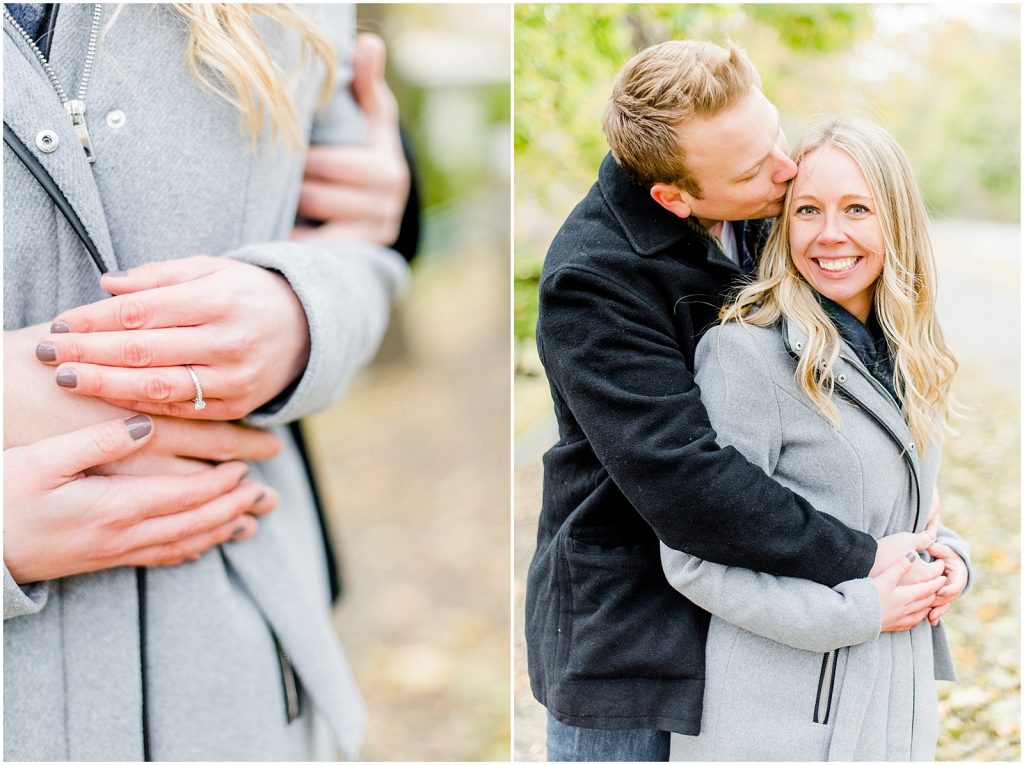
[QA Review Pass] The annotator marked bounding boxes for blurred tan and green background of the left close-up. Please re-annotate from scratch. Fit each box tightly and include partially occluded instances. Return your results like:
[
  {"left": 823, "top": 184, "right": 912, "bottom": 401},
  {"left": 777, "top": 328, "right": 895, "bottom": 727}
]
[{"left": 307, "top": 4, "right": 511, "bottom": 761}]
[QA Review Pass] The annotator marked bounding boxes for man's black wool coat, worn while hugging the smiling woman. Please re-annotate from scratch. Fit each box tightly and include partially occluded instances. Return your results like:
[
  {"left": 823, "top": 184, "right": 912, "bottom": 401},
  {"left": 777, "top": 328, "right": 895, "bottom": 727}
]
[{"left": 526, "top": 155, "right": 877, "bottom": 734}]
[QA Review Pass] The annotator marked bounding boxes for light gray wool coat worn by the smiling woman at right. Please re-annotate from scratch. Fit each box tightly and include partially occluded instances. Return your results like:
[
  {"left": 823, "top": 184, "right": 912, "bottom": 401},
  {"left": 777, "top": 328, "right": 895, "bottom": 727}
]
[{"left": 662, "top": 323, "right": 970, "bottom": 761}]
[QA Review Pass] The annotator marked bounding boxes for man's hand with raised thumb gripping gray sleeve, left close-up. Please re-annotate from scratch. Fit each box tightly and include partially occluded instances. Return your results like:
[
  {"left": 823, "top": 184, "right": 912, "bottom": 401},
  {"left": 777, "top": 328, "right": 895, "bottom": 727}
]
[{"left": 292, "top": 33, "right": 410, "bottom": 246}]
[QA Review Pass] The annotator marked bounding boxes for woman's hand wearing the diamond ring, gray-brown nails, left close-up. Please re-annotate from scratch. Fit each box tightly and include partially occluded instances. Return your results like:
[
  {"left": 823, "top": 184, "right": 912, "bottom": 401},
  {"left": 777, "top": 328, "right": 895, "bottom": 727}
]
[{"left": 36, "top": 256, "right": 309, "bottom": 420}]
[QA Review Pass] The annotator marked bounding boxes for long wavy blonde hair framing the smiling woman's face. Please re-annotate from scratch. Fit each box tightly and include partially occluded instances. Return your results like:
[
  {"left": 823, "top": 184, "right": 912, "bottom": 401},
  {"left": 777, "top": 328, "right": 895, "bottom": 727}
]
[{"left": 721, "top": 116, "right": 956, "bottom": 451}]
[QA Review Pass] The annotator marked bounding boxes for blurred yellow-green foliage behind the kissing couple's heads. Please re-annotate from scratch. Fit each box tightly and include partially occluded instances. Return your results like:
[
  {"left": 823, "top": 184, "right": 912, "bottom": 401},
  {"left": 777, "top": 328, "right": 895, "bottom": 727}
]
[{"left": 514, "top": 3, "right": 1020, "bottom": 340}]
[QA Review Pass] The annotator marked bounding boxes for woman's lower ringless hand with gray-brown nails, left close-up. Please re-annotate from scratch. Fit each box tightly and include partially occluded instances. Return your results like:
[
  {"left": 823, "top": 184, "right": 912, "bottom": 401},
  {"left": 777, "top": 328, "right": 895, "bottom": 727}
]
[{"left": 3, "top": 415, "right": 279, "bottom": 584}]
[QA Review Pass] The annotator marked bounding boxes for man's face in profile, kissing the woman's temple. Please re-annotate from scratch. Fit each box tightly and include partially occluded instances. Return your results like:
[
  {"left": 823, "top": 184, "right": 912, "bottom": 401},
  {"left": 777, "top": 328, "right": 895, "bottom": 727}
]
[{"left": 655, "top": 88, "right": 797, "bottom": 227}]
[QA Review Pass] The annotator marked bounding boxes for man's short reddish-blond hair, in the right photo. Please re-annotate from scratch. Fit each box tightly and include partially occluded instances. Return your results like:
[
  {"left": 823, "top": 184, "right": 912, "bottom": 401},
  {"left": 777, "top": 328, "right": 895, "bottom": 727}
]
[{"left": 603, "top": 40, "right": 761, "bottom": 192}]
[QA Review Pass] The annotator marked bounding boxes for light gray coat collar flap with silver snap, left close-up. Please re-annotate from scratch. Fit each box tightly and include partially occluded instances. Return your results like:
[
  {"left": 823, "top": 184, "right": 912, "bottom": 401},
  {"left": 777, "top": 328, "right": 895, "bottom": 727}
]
[{"left": 3, "top": 13, "right": 118, "bottom": 270}]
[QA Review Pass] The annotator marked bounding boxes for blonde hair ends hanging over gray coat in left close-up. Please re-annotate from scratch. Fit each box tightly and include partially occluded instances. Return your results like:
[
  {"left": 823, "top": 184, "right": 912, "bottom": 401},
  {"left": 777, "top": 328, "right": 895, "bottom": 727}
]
[{"left": 108, "top": 3, "right": 337, "bottom": 148}]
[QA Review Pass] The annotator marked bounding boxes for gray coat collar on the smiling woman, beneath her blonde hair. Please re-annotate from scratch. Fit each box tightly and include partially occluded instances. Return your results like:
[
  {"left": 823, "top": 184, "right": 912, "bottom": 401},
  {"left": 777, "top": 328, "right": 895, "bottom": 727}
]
[{"left": 782, "top": 316, "right": 921, "bottom": 476}]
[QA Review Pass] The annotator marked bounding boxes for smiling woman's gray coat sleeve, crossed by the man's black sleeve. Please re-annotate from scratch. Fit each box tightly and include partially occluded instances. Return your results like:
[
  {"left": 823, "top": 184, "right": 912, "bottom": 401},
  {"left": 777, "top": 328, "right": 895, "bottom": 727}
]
[{"left": 662, "top": 325, "right": 882, "bottom": 652}]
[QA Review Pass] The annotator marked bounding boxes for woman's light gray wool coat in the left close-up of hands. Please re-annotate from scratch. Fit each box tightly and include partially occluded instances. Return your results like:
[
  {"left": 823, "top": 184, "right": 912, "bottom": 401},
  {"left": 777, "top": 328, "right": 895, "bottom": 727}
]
[{"left": 3, "top": 3, "right": 406, "bottom": 760}]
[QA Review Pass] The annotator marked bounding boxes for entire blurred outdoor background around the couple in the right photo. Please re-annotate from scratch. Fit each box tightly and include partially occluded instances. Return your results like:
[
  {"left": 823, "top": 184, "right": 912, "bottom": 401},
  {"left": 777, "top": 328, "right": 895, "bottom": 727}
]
[{"left": 513, "top": 3, "right": 1021, "bottom": 761}]
